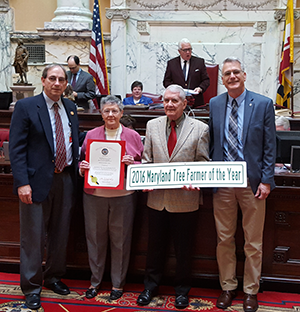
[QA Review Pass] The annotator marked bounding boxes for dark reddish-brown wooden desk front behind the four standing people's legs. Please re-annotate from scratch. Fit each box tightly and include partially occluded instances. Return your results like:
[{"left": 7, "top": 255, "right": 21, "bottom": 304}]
[{"left": 0, "top": 173, "right": 300, "bottom": 289}]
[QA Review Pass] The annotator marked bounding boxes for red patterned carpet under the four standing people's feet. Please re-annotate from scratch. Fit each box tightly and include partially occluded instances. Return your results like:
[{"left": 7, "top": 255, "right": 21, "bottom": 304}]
[{"left": 0, "top": 273, "right": 300, "bottom": 312}]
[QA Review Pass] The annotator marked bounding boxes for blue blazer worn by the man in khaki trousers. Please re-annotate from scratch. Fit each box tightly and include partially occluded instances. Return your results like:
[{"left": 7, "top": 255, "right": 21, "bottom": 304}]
[{"left": 209, "top": 90, "right": 276, "bottom": 194}]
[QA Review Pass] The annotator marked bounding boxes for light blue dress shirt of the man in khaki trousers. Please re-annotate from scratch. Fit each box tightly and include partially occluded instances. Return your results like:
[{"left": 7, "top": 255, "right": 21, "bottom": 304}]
[{"left": 224, "top": 90, "right": 246, "bottom": 160}]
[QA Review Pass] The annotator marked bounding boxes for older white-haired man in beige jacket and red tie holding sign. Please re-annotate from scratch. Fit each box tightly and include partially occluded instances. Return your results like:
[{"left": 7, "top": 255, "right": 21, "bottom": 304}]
[{"left": 137, "top": 85, "right": 209, "bottom": 308}]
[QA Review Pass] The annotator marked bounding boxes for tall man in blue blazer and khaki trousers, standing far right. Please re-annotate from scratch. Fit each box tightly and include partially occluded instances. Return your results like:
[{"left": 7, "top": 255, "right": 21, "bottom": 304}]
[{"left": 209, "top": 58, "right": 276, "bottom": 312}]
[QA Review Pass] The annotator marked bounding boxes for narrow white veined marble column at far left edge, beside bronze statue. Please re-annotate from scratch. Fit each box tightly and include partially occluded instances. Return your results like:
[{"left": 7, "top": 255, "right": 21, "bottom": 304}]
[{"left": 0, "top": 0, "right": 13, "bottom": 92}]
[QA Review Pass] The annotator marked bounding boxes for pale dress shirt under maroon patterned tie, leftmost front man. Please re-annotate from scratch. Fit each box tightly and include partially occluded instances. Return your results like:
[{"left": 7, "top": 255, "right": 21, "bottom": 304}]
[{"left": 43, "top": 92, "right": 73, "bottom": 166}]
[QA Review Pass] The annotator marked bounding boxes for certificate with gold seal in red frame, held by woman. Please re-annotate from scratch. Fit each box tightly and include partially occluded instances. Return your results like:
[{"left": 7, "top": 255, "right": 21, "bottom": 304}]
[{"left": 84, "top": 139, "right": 125, "bottom": 190}]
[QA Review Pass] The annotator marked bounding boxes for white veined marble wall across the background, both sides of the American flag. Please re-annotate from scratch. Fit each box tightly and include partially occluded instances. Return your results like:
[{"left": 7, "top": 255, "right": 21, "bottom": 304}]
[{"left": 0, "top": 0, "right": 300, "bottom": 110}]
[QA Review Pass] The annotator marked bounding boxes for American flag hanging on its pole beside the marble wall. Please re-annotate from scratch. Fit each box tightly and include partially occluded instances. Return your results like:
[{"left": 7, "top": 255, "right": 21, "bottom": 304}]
[{"left": 89, "top": 0, "right": 109, "bottom": 100}]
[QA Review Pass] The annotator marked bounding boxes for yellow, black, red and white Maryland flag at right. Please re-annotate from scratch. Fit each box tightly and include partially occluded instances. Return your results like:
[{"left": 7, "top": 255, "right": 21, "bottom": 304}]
[{"left": 276, "top": 0, "right": 294, "bottom": 108}]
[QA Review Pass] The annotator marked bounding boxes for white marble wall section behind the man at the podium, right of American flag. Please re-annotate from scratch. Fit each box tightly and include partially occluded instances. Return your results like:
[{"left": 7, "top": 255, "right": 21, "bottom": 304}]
[{"left": 106, "top": 0, "right": 298, "bottom": 111}]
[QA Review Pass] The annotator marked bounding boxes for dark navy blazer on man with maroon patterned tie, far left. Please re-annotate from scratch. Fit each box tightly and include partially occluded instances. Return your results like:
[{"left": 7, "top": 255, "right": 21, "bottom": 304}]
[{"left": 9, "top": 93, "right": 81, "bottom": 202}]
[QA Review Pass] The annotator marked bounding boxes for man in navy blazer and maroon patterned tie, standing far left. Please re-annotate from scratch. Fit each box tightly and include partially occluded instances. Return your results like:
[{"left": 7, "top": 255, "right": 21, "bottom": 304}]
[{"left": 9, "top": 64, "right": 83, "bottom": 309}]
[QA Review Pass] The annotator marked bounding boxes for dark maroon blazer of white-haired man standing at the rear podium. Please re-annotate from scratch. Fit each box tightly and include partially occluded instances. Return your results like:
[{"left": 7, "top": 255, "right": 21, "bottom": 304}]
[{"left": 163, "top": 56, "right": 210, "bottom": 107}]
